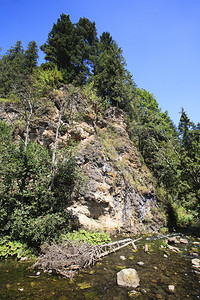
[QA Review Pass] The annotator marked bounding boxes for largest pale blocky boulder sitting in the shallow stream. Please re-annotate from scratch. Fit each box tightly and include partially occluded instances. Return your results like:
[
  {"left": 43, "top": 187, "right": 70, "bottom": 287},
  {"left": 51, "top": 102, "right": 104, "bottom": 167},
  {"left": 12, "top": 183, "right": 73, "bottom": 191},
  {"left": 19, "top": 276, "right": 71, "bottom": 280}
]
[{"left": 117, "top": 269, "right": 140, "bottom": 288}]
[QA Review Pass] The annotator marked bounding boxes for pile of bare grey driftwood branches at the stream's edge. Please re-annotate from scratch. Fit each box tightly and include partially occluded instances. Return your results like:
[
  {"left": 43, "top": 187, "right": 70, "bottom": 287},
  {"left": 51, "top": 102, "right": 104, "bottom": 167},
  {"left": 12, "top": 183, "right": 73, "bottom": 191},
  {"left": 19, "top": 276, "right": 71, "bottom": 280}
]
[{"left": 32, "top": 239, "right": 139, "bottom": 278}]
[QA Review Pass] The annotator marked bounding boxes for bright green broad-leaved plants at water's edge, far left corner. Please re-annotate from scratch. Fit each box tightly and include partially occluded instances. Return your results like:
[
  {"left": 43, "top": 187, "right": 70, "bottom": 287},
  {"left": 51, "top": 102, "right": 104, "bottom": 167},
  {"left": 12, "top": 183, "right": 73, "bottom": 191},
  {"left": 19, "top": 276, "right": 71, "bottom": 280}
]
[{"left": 0, "top": 236, "right": 33, "bottom": 259}]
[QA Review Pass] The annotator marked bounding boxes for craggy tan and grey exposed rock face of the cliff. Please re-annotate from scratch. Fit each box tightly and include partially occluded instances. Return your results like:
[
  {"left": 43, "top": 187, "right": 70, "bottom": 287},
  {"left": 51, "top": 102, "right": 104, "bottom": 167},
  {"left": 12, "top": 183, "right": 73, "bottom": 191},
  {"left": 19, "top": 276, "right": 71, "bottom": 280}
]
[{"left": 0, "top": 86, "right": 166, "bottom": 233}]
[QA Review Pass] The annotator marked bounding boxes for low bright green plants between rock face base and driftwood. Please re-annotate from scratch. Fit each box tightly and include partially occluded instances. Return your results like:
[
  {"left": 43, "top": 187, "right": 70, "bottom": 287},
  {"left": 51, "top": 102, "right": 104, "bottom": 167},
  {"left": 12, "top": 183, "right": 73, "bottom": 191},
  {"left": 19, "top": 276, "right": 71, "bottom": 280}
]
[{"left": 62, "top": 230, "right": 111, "bottom": 245}]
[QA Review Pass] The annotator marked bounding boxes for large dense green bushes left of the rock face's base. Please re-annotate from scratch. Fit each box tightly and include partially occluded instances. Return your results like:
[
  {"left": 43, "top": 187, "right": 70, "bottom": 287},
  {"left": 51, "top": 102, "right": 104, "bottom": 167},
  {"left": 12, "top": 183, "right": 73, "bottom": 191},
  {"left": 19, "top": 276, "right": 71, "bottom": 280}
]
[{"left": 0, "top": 122, "right": 81, "bottom": 247}]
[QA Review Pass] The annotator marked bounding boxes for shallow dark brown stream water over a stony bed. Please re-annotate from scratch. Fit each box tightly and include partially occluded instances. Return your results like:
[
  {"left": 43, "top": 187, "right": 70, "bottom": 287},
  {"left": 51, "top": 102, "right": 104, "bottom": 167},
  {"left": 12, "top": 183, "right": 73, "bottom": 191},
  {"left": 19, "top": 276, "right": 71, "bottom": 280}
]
[{"left": 0, "top": 234, "right": 200, "bottom": 300}]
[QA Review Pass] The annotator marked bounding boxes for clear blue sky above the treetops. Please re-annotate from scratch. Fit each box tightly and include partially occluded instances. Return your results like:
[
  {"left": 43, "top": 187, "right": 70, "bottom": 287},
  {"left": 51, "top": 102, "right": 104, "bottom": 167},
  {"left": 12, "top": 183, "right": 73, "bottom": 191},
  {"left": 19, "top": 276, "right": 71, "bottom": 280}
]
[{"left": 0, "top": 0, "right": 200, "bottom": 125}]
